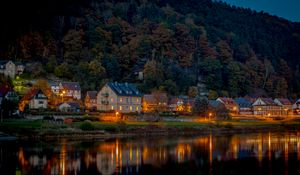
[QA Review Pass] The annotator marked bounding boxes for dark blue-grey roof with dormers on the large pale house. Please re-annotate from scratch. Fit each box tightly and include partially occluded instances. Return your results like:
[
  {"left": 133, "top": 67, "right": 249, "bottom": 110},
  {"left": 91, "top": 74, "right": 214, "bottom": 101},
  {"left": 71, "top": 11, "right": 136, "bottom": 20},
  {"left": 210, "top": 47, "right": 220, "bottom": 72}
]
[{"left": 107, "top": 82, "right": 142, "bottom": 97}]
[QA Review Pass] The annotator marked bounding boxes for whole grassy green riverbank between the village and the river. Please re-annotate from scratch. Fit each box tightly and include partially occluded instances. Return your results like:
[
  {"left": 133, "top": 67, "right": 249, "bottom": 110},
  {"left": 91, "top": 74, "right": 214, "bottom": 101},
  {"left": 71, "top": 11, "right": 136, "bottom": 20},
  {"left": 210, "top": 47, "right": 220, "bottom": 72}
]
[{"left": 0, "top": 119, "right": 300, "bottom": 140}]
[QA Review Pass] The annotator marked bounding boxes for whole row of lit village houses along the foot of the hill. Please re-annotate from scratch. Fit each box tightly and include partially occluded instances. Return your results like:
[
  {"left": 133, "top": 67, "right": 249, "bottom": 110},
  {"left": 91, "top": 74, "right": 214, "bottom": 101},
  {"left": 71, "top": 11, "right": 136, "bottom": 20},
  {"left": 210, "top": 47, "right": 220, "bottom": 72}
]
[{"left": 0, "top": 61, "right": 300, "bottom": 119}]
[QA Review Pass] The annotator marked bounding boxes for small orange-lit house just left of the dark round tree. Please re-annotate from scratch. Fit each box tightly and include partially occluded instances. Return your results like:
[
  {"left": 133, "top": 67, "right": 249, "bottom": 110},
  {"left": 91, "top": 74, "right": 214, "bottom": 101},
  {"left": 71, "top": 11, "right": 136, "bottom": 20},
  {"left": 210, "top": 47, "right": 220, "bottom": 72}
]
[{"left": 169, "top": 96, "right": 195, "bottom": 113}]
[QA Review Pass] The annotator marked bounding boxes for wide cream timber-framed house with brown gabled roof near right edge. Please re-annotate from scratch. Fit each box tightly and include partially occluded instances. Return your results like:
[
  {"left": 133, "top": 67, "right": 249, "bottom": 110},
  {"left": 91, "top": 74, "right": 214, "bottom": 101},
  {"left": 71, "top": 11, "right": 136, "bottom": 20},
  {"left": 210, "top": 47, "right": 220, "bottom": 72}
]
[{"left": 252, "top": 98, "right": 281, "bottom": 117}]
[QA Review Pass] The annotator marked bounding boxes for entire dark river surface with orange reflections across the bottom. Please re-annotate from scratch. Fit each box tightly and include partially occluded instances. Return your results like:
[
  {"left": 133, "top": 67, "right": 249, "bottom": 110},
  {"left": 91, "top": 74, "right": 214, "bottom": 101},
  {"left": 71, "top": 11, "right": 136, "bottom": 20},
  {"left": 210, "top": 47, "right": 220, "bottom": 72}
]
[{"left": 0, "top": 133, "right": 300, "bottom": 175}]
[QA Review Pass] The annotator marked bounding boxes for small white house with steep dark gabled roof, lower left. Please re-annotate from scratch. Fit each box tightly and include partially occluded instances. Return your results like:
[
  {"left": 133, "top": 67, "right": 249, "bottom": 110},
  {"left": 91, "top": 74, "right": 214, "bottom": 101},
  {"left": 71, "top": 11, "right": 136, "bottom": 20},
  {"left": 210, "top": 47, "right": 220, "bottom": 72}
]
[{"left": 29, "top": 90, "right": 48, "bottom": 109}]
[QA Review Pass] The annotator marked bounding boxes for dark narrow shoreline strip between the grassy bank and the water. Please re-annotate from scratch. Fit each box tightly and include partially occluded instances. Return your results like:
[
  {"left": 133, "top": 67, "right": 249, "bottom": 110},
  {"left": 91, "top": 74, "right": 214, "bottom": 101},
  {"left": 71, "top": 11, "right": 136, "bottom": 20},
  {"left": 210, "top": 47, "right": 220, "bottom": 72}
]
[{"left": 6, "top": 125, "right": 300, "bottom": 141}]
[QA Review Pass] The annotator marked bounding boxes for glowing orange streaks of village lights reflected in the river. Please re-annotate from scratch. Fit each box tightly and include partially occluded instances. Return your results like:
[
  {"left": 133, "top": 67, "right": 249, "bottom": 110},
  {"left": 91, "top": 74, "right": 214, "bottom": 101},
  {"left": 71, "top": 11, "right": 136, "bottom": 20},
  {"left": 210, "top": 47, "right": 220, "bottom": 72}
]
[{"left": 8, "top": 132, "right": 300, "bottom": 175}]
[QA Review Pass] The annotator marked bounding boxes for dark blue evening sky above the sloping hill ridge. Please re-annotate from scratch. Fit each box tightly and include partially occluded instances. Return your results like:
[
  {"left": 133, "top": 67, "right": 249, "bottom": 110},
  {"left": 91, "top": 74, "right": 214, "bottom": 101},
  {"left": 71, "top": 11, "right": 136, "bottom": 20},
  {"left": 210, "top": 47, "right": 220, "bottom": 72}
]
[{"left": 218, "top": 0, "right": 300, "bottom": 22}]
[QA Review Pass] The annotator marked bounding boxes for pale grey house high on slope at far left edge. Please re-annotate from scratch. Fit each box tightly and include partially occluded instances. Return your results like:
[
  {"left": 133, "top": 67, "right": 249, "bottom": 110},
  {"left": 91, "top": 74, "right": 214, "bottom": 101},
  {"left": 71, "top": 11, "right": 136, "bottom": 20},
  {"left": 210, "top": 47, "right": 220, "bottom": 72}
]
[{"left": 0, "top": 60, "right": 25, "bottom": 78}]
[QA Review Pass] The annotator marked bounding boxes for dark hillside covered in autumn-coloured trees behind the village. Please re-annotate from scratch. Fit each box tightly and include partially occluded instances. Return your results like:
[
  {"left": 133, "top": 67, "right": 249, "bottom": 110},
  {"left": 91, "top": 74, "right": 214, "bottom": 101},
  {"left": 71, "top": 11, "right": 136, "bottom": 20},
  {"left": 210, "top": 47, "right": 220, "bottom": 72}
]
[{"left": 0, "top": 0, "right": 300, "bottom": 97}]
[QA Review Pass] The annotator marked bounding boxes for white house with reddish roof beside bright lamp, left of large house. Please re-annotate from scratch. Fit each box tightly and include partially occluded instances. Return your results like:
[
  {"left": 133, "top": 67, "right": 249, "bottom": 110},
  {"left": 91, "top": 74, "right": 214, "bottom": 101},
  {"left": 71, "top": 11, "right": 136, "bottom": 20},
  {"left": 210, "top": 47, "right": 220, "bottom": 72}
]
[{"left": 59, "top": 82, "right": 81, "bottom": 100}]
